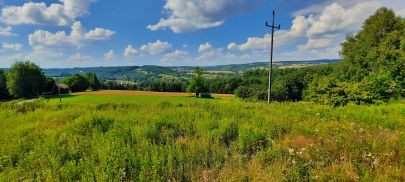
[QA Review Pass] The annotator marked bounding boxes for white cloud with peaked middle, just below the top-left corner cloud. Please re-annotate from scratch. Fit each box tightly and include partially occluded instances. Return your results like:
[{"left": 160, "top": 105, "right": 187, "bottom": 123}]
[{"left": 28, "top": 22, "right": 115, "bottom": 47}]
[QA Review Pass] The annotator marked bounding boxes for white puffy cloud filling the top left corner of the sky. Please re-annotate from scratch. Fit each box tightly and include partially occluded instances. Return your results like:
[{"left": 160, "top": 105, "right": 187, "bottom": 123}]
[{"left": 0, "top": 0, "right": 95, "bottom": 26}]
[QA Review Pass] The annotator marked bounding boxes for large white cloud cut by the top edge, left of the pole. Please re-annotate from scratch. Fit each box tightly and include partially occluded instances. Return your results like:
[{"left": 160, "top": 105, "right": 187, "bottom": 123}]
[{"left": 147, "top": 0, "right": 264, "bottom": 33}]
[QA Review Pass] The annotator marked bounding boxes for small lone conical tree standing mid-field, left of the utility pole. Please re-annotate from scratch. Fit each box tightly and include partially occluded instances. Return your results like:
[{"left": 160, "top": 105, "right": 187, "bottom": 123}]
[{"left": 187, "top": 67, "right": 208, "bottom": 97}]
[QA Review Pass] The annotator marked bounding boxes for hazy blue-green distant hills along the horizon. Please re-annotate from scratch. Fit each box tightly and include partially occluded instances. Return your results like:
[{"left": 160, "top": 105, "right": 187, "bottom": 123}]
[{"left": 4, "top": 59, "right": 338, "bottom": 82}]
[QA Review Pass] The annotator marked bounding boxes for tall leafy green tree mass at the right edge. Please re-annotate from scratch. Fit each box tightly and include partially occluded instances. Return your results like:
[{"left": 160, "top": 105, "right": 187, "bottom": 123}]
[{"left": 306, "top": 8, "right": 405, "bottom": 105}]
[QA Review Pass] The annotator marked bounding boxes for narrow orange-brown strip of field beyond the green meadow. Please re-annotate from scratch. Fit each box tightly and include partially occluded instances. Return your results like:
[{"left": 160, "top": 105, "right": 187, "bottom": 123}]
[{"left": 74, "top": 90, "right": 234, "bottom": 97}]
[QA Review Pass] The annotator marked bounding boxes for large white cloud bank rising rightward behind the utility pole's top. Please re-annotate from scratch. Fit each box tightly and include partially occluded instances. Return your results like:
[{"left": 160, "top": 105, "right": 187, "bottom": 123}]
[{"left": 228, "top": 0, "right": 381, "bottom": 58}]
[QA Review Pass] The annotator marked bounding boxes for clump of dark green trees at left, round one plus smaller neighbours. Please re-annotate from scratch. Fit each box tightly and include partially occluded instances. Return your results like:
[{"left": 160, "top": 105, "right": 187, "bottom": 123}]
[{"left": 0, "top": 62, "right": 102, "bottom": 101}]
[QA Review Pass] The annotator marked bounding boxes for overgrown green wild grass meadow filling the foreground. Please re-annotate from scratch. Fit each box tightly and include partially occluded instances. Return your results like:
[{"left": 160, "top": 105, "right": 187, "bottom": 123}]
[{"left": 0, "top": 95, "right": 405, "bottom": 181}]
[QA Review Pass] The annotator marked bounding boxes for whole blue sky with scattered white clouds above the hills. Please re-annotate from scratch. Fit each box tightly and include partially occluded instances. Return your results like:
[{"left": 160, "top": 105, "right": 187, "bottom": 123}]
[{"left": 0, "top": 0, "right": 405, "bottom": 68}]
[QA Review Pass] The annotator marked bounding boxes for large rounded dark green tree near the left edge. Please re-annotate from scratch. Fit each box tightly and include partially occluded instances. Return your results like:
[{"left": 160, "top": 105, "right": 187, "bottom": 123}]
[{"left": 7, "top": 62, "right": 46, "bottom": 98}]
